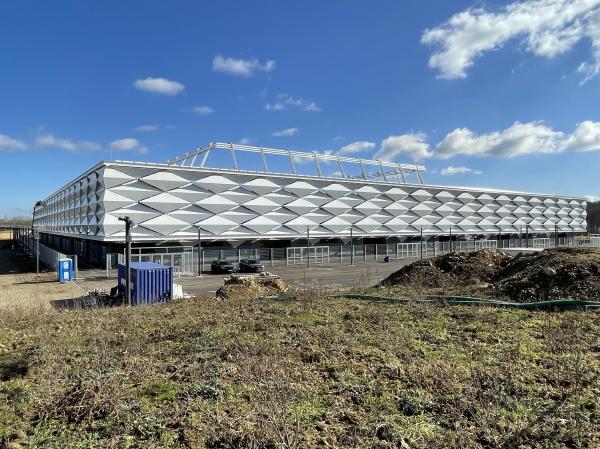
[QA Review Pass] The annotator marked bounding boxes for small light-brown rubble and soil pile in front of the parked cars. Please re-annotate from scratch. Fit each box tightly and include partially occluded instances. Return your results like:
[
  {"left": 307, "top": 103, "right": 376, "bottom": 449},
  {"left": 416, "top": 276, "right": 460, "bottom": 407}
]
[{"left": 216, "top": 272, "right": 289, "bottom": 299}]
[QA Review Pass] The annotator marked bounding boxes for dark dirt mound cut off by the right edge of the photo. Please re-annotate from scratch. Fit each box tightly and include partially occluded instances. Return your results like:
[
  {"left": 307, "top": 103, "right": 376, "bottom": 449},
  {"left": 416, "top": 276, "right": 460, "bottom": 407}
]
[{"left": 489, "top": 248, "right": 600, "bottom": 302}]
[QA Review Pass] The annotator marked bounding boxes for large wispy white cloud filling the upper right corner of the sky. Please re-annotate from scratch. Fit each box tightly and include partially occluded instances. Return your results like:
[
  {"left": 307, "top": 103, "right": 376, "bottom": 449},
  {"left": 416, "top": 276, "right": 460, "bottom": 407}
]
[{"left": 421, "top": 0, "right": 600, "bottom": 81}]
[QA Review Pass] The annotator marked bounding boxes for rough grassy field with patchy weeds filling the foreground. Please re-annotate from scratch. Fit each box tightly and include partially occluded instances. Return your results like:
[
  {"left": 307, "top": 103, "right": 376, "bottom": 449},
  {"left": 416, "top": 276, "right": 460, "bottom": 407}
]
[{"left": 0, "top": 299, "right": 600, "bottom": 449}]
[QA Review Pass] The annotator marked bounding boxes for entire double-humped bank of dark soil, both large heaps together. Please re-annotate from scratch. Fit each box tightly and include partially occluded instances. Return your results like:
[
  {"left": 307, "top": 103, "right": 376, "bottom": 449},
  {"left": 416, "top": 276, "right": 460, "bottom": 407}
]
[{"left": 381, "top": 248, "right": 600, "bottom": 302}]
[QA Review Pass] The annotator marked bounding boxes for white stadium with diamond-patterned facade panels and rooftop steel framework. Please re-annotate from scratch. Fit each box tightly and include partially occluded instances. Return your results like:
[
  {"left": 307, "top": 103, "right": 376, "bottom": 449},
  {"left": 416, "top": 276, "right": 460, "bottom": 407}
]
[{"left": 35, "top": 143, "right": 587, "bottom": 242}]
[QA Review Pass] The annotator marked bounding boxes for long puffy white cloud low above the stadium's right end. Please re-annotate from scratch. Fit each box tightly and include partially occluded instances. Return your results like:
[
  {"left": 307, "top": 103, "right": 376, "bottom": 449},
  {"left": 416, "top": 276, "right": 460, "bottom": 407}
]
[{"left": 435, "top": 121, "right": 600, "bottom": 159}]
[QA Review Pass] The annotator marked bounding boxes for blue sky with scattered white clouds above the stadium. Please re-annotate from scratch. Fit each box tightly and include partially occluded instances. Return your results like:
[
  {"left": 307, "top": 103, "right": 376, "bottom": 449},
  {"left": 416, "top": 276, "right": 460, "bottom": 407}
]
[{"left": 0, "top": 0, "right": 600, "bottom": 215}]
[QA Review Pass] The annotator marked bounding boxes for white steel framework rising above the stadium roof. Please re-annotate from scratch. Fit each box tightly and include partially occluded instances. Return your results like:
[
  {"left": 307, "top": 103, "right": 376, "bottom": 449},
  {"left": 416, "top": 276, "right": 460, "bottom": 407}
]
[{"left": 167, "top": 142, "right": 425, "bottom": 185}]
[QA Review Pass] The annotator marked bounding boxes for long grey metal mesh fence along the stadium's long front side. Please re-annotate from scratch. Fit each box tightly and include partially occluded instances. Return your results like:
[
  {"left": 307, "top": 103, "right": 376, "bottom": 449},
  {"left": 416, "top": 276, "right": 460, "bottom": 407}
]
[{"left": 106, "top": 236, "right": 600, "bottom": 277}]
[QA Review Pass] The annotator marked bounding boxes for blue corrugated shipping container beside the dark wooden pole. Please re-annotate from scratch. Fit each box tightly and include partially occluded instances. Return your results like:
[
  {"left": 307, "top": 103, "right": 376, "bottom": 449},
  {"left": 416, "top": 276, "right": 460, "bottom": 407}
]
[{"left": 119, "top": 262, "right": 173, "bottom": 306}]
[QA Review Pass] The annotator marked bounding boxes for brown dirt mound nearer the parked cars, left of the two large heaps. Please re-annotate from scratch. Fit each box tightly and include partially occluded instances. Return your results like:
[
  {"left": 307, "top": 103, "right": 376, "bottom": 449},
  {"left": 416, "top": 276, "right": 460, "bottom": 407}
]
[{"left": 381, "top": 250, "right": 511, "bottom": 288}]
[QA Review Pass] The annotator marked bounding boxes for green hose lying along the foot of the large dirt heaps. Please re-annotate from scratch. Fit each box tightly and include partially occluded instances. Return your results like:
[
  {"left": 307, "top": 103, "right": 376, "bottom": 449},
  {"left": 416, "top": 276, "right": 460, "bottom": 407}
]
[{"left": 329, "top": 293, "right": 600, "bottom": 310}]
